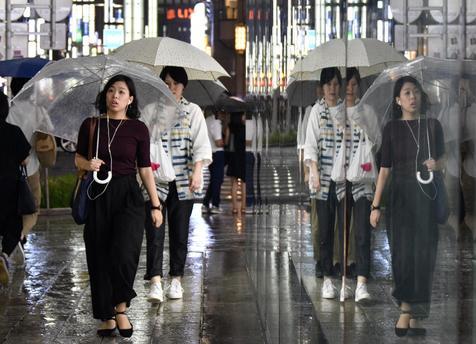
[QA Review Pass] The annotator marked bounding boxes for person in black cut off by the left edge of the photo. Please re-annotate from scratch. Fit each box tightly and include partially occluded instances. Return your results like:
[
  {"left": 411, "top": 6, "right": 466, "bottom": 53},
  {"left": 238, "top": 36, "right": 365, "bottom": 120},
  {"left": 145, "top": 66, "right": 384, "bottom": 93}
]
[{"left": 0, "top": 92, "right": 31, "bottom": 286}]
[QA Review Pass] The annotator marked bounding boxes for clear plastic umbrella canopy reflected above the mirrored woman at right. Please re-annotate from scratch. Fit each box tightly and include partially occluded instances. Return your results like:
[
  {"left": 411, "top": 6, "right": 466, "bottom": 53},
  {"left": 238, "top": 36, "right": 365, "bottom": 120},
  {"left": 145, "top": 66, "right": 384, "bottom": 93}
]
[{"left": 355, "top": 57, "right": 466, "bottom": 145}]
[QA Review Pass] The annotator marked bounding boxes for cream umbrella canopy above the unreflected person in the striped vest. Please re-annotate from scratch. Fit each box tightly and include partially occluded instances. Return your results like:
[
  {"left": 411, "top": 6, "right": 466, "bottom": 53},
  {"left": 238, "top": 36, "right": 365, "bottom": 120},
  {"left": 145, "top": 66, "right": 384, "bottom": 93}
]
[{"left": 113, "top": 37, "right": 230, "bottom": 80}]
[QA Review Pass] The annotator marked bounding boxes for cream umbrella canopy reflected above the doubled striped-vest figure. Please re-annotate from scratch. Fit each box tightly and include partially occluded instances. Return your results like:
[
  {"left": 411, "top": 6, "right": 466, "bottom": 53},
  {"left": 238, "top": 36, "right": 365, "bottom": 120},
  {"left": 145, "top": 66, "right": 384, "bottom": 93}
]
[{"left": 290, "top": 38, "right": 406, "bottom": 80}]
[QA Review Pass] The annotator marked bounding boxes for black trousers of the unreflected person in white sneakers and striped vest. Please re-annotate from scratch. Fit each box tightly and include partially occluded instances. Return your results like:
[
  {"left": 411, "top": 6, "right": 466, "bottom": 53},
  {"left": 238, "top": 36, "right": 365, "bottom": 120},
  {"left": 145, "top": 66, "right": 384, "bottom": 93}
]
[{"left": 144, "top": 181, "right": 193, "bottom": 280}]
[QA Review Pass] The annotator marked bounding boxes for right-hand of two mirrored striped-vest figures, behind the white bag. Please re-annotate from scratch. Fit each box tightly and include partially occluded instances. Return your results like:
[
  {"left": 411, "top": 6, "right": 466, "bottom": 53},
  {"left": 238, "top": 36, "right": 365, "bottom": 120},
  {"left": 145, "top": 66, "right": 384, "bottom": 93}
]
[{"left": 345, "top": 68, "right": 373, "bottom": 302}]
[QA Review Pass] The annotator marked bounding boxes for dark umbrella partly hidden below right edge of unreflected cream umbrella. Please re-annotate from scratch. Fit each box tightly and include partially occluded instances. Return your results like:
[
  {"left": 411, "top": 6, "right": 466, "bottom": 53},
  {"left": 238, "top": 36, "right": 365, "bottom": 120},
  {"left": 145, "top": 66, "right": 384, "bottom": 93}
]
[{"left": 183, "top": 80, "right": 227, "bottom": 106}]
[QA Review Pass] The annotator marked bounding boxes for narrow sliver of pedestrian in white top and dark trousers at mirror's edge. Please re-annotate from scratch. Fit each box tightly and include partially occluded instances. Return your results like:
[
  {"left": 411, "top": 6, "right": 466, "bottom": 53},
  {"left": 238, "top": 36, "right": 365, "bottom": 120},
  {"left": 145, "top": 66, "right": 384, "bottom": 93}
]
[{"left": 245, "top": 113, "right": 256, "bottom": 214}]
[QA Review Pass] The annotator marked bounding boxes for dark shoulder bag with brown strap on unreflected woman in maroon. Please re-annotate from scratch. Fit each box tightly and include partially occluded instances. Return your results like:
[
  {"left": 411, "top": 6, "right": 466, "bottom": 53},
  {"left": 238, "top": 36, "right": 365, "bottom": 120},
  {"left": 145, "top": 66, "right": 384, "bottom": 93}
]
[{"left": 71, "top": 117, "right": 97, "bottom": 225}]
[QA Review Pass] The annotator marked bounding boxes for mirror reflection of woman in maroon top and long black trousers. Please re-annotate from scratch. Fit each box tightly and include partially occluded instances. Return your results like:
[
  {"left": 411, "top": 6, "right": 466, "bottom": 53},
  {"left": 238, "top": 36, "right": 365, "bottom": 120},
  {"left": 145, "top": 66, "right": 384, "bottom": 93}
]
[{"left": 370, "top": 76, "right": 444, "bottom": 336}]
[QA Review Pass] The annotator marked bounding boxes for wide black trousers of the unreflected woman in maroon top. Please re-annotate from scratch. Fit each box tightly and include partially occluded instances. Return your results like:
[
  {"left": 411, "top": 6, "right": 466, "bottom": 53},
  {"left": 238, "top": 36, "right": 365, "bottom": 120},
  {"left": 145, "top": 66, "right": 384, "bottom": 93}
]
[{"left": 84, "top": 174, "right": 145, "bottom": 320}]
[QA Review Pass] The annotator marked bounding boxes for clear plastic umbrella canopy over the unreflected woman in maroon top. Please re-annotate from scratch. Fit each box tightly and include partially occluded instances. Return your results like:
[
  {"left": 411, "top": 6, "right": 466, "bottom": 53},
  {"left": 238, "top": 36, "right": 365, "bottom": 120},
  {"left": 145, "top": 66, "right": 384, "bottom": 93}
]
[{"left": 8, "top": 56, "right": 178, "bottom": 142}]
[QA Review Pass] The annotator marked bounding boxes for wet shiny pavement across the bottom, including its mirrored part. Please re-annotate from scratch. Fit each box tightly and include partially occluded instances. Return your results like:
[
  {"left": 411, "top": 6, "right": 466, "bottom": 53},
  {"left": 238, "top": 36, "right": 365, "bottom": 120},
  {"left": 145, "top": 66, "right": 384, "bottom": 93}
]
[{"left": 0, "top": 199, "right": 474, "bottom": 344}]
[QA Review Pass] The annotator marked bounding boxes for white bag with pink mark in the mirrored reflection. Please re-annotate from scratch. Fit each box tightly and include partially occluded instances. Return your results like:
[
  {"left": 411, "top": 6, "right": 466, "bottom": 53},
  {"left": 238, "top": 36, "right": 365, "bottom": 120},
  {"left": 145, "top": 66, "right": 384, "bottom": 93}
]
[{"left": 347, "top": 132, "right": 377, "bottom": 183}]
